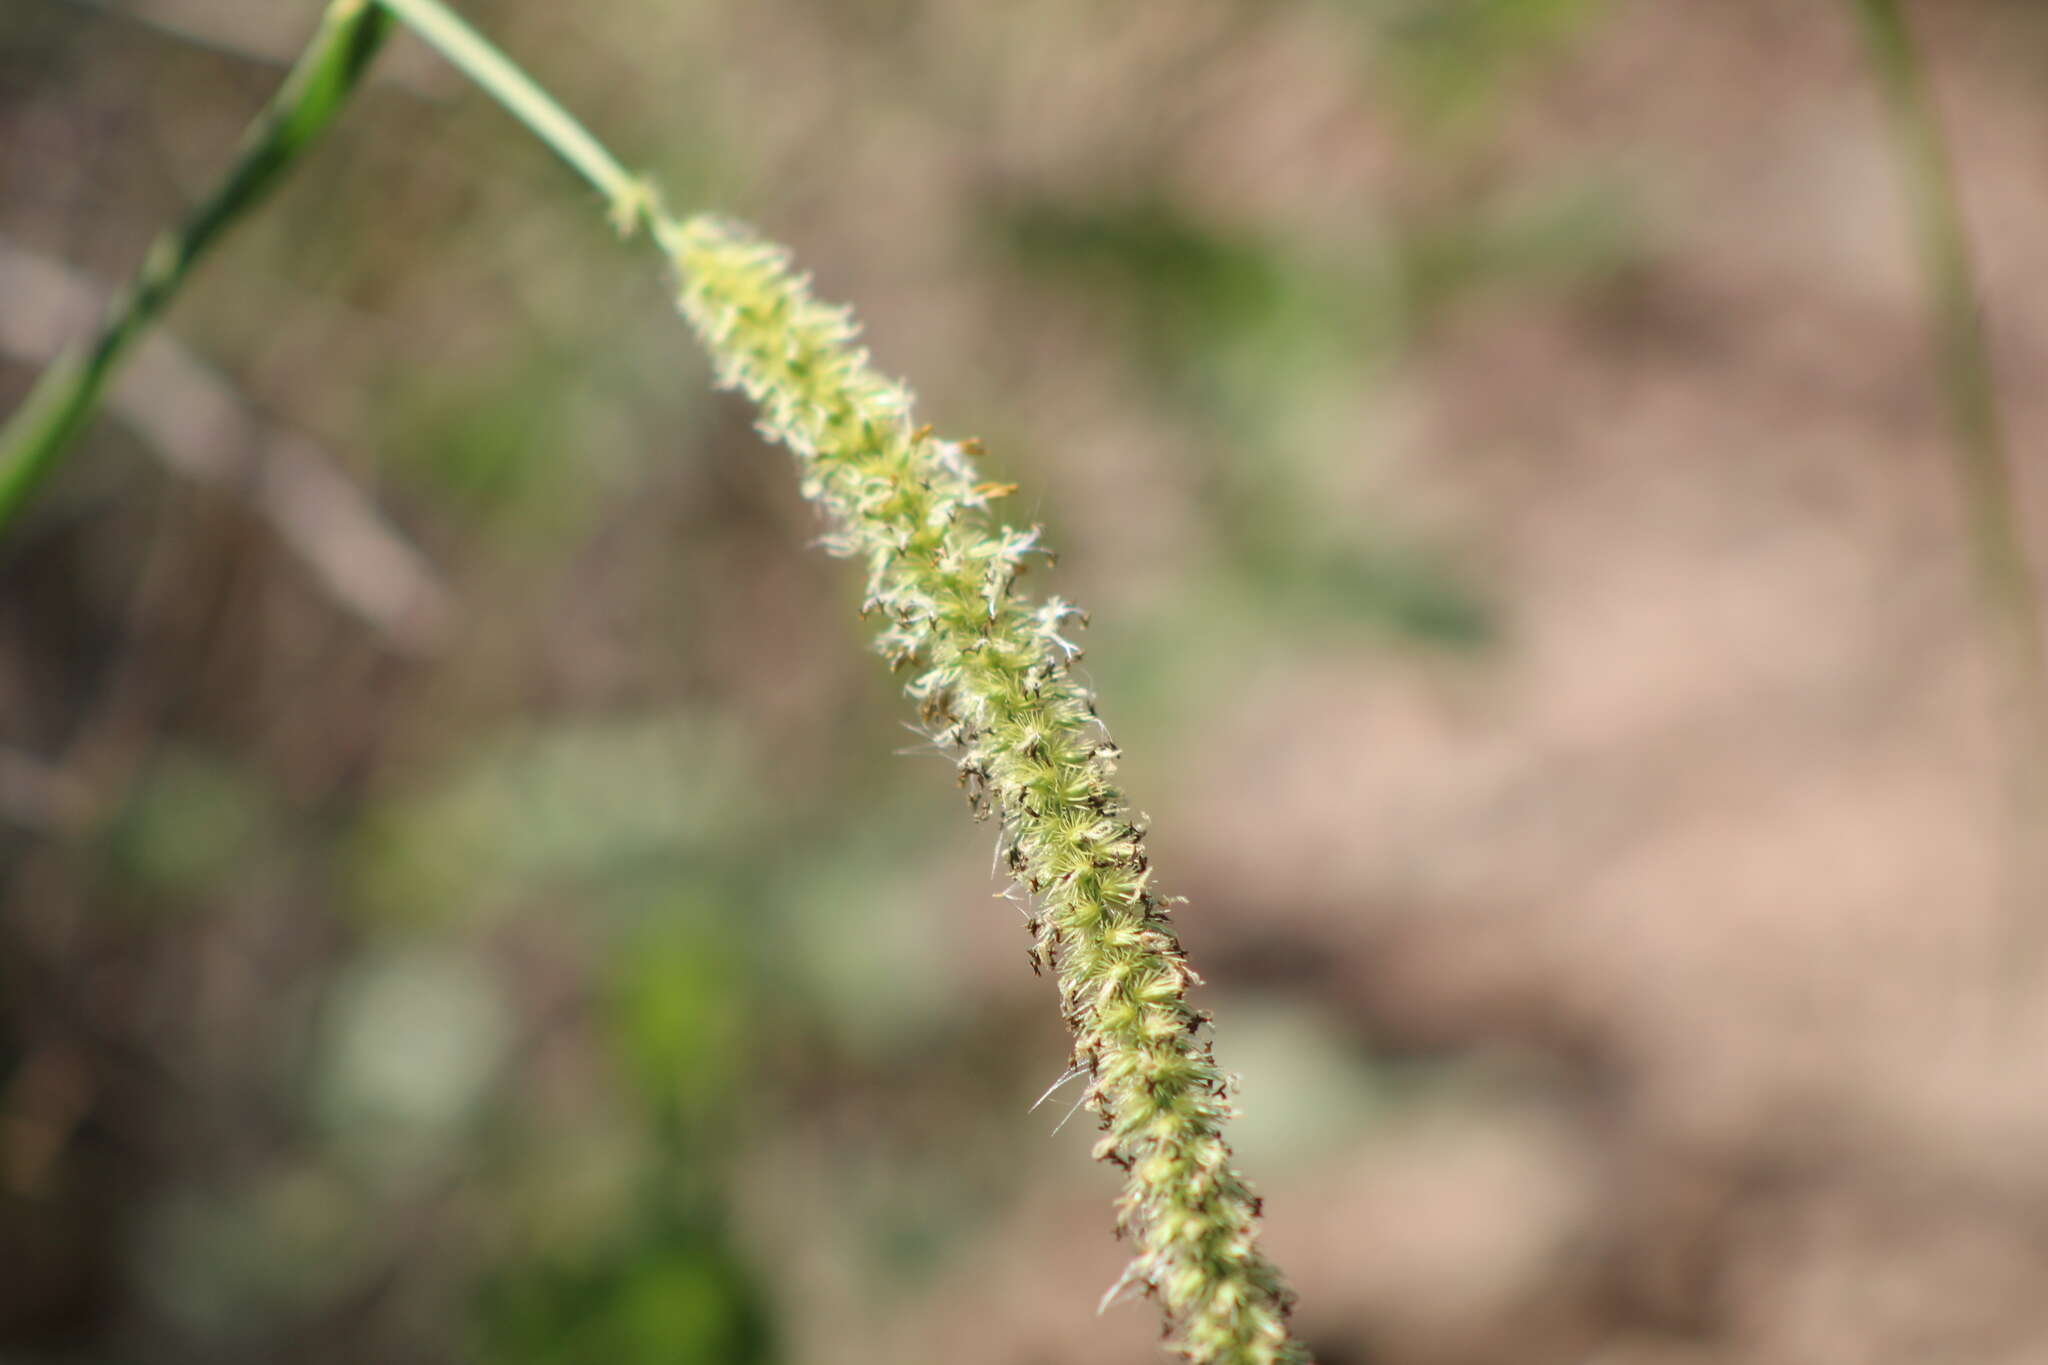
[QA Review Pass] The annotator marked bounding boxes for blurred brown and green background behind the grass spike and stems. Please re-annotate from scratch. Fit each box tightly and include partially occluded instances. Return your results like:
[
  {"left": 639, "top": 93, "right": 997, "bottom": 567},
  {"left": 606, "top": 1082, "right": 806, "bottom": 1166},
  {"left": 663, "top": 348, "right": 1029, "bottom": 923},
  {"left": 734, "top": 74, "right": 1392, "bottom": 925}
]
[{"left": 0, "top": 0, "right": 2048, "bottom": 1365}]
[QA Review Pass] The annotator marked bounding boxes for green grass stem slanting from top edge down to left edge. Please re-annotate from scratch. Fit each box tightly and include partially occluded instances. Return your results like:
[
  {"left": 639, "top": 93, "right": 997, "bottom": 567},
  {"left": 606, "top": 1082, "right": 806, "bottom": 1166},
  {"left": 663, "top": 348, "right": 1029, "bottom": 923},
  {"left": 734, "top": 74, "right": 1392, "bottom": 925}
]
[{"left": 0, "top": 0, "right": 391, "bottom": 532}]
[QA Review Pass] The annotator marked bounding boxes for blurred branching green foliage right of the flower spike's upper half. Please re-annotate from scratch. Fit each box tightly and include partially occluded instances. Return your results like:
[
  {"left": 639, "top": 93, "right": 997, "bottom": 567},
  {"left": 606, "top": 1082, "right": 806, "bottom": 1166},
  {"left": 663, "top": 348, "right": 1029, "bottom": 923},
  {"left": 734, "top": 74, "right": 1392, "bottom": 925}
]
[{"left": 999, "top": 186, "right": 1630, "bottom": 647}]
